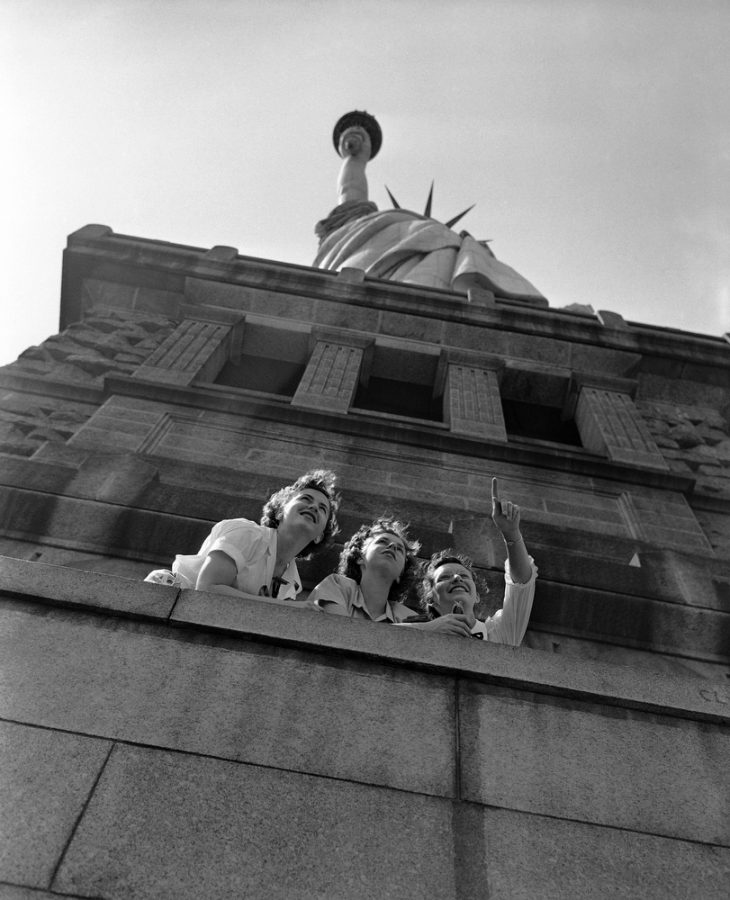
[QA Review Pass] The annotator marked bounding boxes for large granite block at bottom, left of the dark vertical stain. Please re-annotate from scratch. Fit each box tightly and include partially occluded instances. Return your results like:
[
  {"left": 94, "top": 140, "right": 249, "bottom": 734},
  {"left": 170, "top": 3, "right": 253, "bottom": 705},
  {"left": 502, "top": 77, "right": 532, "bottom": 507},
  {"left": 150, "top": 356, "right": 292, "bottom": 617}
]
[{"left": 53, "top": 747, "right": 454, "bottom": 900}]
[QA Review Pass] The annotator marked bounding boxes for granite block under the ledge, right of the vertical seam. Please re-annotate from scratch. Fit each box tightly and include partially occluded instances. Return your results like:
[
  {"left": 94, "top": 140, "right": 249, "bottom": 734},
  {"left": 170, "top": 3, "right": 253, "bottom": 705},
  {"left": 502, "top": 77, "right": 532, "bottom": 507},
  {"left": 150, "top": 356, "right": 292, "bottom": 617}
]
[{"left": 460, "top": 685, "right": 730, "bottom": 846}]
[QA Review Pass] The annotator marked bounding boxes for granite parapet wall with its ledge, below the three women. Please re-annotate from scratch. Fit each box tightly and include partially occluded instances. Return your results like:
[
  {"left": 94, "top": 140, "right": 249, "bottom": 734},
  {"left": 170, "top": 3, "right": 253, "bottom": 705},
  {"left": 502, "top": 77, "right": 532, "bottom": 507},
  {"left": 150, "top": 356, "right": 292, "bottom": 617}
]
[{"left": 0, "top": 559, "right": 730, "bottom": 900}]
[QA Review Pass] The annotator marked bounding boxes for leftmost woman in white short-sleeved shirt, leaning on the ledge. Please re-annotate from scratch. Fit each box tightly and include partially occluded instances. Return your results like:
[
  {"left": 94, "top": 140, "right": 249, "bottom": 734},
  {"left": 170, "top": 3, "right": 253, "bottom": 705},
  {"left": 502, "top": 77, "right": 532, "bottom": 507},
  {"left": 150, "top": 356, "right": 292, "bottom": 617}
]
[{"left": 145, "top": 469, "right": 340, "bottom": 601}]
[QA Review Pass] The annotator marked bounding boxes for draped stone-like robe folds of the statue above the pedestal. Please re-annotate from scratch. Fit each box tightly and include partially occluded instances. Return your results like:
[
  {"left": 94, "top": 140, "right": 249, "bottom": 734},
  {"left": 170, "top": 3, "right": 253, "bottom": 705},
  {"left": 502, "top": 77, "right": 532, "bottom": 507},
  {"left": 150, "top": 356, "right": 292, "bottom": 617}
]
[{"left": 313, "top": 203, "right": 544, "bottom": 301}]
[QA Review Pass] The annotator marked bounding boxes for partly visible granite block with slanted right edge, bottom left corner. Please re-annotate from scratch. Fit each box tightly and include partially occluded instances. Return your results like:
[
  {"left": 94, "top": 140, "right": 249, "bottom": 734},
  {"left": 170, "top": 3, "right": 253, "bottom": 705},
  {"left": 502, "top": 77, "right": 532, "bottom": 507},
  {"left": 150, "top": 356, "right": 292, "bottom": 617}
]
[{"left": 0, "top": 720, "right": 110, "bottom": 897}]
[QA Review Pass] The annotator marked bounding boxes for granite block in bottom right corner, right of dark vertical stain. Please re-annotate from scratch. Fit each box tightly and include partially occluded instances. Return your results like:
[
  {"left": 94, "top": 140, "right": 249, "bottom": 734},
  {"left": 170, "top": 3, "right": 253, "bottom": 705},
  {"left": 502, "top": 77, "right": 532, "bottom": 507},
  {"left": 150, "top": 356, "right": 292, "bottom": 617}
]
[{"left": 478, "top": 809, "right": 730, "bottom": 900}]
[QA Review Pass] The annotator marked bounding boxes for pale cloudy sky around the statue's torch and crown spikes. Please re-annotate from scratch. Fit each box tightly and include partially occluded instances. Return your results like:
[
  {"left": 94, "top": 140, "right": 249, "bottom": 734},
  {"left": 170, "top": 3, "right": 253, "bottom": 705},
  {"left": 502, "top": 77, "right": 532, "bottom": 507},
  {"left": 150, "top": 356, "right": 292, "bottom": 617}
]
[{"left": 0, "top": 0, "right": 730, "bottom": 364}]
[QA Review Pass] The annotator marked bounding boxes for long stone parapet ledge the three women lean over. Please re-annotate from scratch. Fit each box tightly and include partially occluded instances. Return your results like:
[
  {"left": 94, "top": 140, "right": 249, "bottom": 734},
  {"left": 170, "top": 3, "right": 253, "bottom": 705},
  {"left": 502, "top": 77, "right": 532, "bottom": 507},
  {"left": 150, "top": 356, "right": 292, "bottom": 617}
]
[{"left": 0, "top": 557, "right": 730, "bottom": 722}]
